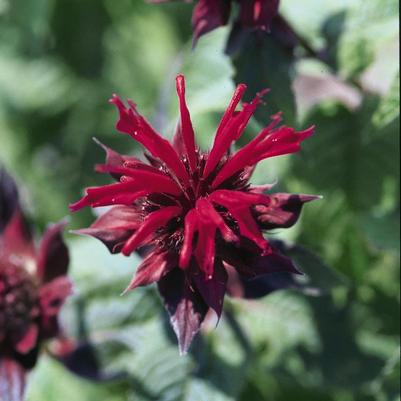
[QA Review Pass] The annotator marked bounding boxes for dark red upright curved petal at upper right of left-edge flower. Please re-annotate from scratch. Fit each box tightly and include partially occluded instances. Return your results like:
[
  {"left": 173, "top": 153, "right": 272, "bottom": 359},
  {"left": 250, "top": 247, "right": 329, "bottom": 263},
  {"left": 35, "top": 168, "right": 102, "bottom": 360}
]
[{"left": 37, "top": 222, "right": 69, "bottom": 282}]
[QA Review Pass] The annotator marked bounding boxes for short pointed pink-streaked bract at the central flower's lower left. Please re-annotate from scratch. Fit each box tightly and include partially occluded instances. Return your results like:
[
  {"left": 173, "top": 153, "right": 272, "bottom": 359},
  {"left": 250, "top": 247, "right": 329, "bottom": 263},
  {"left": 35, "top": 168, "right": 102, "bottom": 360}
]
[{"left": 123, "top": 251, "right": 177, "bottom": 294}]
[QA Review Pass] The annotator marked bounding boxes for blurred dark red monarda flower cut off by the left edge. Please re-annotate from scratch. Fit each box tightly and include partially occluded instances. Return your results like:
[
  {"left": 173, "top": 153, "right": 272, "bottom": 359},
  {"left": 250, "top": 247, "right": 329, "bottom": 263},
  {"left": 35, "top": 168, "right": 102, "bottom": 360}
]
[{"left": 0, "top": 171, "right": 71, "bottom": 400}]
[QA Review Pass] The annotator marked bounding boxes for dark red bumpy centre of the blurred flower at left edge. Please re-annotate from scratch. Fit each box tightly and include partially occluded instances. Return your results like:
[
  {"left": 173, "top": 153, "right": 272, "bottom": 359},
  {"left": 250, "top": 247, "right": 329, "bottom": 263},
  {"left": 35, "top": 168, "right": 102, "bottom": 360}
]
[{"left": 0, "top": 263, "right": 39, "bottom": 341}]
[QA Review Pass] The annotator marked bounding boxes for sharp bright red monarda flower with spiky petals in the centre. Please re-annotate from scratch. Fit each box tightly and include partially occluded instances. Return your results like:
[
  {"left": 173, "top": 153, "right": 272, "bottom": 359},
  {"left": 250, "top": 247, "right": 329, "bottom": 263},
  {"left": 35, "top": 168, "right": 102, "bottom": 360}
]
[{"left": 70, "top": 75, "right": 316, "bottom": 352}]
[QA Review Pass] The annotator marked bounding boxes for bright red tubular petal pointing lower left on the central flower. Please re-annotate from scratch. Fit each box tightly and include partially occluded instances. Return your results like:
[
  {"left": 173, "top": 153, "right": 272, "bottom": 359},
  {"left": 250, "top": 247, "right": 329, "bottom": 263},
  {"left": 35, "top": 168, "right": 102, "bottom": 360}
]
[{"left": 121, "top": 206, "right": 181, "bottom": 256}]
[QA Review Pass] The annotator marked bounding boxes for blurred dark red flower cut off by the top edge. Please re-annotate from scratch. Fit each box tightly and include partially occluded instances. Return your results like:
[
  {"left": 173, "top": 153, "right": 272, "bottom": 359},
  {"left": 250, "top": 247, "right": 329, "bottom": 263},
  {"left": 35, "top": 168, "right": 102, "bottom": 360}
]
[{"left": 149, "top": 0, "right": 279, "bottom": 42}]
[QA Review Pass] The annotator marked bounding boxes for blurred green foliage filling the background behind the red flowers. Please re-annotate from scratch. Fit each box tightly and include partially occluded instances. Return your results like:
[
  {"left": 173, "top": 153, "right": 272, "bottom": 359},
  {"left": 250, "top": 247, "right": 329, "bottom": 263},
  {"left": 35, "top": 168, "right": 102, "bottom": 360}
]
[{"left": 0, "top": 0, "right": 400, "bottom": 401}]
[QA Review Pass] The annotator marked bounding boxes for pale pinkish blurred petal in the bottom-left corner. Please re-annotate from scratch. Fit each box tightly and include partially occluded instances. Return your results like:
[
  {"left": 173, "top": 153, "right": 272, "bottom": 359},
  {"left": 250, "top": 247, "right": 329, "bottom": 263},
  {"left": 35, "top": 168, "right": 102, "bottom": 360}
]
[{"left": 0, "top": 357, "right": 26, "bottom": 401}]
